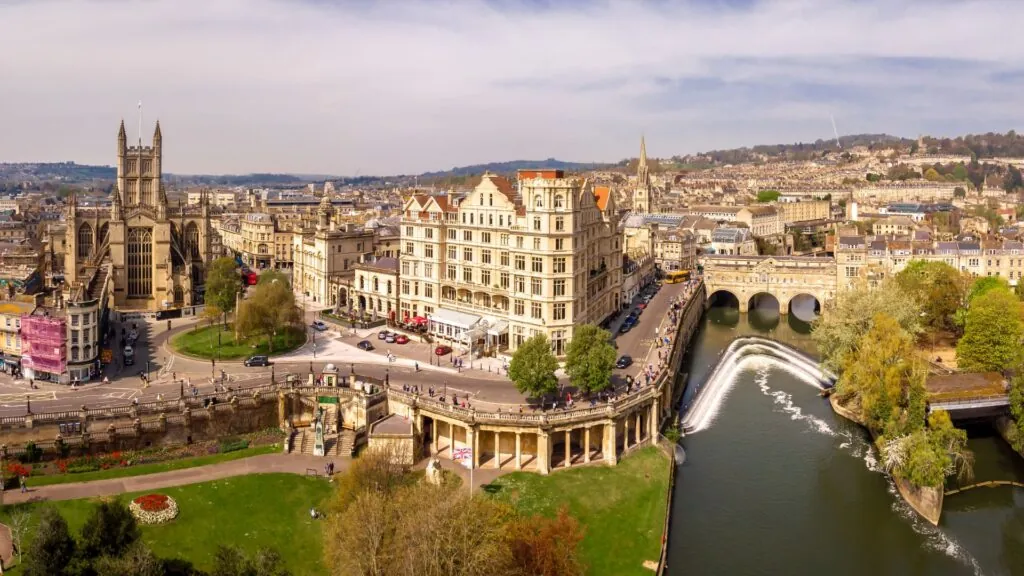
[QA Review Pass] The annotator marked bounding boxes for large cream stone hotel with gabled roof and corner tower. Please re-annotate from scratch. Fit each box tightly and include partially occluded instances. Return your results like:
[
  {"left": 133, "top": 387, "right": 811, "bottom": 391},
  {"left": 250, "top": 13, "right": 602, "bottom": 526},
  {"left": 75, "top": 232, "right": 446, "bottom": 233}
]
[{"left": 399, "top": 170, "right": 623, "bottom": 356}]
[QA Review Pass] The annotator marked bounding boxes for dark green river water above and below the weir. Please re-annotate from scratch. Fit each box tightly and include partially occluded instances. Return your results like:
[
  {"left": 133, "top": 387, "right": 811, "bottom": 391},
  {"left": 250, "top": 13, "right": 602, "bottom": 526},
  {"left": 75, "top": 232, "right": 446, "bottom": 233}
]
[{"left": 668, "top": 301, "right": 1024, "bottom": 576}]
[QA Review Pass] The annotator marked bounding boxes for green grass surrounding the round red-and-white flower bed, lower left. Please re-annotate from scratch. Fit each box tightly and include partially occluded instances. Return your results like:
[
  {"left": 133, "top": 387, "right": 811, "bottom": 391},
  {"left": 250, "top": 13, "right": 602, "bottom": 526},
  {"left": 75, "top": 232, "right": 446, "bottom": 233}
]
[{"left": 0, "top": 474, "right": 333, "bottom": 576}]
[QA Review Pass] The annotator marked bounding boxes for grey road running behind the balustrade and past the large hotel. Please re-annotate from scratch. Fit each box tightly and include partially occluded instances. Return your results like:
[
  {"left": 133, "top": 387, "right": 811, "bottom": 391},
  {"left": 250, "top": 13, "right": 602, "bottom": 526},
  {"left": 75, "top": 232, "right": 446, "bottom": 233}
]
[{"left": 0, "top": 284, "right": 683, "bottom": 416}]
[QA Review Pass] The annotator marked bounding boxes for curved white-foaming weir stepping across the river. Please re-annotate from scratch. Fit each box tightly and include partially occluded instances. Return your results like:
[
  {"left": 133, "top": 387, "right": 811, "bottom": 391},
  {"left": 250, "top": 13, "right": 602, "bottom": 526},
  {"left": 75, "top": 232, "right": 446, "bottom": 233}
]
[{"left": 681, "top": 336, "right": 836, "bottom": 434}]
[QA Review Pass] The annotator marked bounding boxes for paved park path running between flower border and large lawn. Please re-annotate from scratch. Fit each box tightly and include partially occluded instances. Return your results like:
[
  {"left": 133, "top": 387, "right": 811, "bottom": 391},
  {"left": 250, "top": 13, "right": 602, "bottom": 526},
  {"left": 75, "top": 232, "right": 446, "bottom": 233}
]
[{"left": 3, "top": 454, "right": 339, "bottom": 504}]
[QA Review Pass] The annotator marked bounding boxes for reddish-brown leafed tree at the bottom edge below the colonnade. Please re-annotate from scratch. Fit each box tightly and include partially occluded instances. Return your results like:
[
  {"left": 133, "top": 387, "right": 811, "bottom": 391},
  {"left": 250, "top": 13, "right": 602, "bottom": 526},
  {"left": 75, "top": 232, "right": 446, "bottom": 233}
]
[{"left": 509, "top": 504, "right": 586, "bottom": 576}]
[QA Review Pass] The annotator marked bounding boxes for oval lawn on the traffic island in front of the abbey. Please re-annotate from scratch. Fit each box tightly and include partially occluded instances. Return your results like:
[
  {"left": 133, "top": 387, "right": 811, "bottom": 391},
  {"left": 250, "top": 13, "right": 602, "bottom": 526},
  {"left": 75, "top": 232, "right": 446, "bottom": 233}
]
[{"left": 171, "top": 325, "right": 306, "bottom": 360}]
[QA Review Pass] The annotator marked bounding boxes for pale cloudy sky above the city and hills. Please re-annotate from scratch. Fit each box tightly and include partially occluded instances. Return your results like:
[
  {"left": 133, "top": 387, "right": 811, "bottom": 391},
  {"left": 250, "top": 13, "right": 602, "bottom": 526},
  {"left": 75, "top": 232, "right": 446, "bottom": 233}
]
[{"left": 0, "top": 0, "right": 1024, "bottom": 175}]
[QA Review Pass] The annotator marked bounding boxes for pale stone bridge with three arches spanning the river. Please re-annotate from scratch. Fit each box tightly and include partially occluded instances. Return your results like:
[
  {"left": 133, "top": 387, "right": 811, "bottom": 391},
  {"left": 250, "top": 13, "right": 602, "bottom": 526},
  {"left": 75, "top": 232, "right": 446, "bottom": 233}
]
[{"left": 701, "top": 255, "right": 836, "bottom": 314}]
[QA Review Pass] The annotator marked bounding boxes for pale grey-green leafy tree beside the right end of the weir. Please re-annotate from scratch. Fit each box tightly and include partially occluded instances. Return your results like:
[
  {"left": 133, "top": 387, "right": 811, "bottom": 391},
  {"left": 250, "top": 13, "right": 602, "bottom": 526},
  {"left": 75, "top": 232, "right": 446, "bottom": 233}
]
[{"left": 811, "top": 281, "right": 922, "bottom": 372}]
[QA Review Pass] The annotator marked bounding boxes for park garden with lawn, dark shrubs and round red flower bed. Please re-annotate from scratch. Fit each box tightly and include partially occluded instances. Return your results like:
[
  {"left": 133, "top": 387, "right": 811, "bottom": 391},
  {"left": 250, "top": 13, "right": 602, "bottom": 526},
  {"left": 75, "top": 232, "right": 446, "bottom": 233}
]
[{"left": 0, "top": 474, "right": 331, "bottom": 576}]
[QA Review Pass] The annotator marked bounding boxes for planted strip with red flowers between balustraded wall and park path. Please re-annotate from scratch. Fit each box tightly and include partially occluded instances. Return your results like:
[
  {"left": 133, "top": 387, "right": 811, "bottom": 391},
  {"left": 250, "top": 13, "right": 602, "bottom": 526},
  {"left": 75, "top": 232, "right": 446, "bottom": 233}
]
[{"left": 0, "top": 428, "right": 284, "bottom": 488}]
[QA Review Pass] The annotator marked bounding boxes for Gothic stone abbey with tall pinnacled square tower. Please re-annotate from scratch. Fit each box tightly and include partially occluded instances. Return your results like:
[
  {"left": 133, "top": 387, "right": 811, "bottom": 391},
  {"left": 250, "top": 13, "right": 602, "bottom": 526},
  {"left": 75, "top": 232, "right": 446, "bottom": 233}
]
[{"left": 65, "top": 121, "right": 216, "bottom": 312}]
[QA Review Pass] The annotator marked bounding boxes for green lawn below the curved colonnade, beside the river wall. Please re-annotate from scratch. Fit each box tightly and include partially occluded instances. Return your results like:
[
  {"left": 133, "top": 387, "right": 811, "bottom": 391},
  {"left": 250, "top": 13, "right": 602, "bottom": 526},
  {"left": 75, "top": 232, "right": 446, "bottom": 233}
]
[{"left": 484, "top": 448, "right": 669, "bottom": 576}]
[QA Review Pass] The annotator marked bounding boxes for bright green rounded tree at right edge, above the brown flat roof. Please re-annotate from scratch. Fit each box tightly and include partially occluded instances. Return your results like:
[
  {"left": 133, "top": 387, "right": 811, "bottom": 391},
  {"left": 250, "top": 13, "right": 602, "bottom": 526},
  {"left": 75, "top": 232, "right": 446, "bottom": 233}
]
[{"left": 956, "top": 287, "right": 1024, "bottom": 372}]
